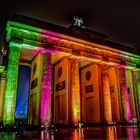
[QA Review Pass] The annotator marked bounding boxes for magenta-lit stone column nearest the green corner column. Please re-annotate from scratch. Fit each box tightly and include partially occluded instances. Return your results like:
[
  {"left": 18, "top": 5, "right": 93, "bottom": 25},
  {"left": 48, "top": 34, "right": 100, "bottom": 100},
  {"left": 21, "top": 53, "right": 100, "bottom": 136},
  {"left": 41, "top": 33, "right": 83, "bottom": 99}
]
[{"left": 40, "top": 54, "right": 51, "bottom": 125}]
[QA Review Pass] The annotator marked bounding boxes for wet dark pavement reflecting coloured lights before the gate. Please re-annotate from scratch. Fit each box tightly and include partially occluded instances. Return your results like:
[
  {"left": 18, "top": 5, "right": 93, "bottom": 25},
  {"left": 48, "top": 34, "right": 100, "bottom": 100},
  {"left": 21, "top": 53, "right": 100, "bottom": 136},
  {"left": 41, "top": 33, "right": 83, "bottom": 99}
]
[{"left": 0, "top": 126, "right": 140, "bottom": 140}]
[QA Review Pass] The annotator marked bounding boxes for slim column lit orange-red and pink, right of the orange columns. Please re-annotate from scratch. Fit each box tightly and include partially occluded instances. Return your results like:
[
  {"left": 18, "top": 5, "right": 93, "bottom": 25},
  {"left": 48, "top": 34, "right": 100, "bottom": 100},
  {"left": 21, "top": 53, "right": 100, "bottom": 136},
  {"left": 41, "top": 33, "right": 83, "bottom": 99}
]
[{"left": 118, "top": 67, "right": 131, "bottom": 122}]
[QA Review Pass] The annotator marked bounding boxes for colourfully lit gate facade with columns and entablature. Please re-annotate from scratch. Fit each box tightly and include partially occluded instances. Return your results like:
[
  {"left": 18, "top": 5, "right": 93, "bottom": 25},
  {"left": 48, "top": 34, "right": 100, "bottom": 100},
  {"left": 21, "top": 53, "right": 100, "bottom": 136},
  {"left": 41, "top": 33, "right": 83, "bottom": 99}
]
[{"left": 0, "top": 14, "right": 140, "bottom": 126}]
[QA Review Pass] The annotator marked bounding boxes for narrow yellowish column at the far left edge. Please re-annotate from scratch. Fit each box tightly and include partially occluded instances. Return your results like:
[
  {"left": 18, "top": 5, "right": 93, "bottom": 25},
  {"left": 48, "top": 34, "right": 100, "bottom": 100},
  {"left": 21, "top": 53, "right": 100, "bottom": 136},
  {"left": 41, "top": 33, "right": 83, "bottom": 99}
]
[{"left": 0, "top": 71, "right": 6, "bottom": 123}]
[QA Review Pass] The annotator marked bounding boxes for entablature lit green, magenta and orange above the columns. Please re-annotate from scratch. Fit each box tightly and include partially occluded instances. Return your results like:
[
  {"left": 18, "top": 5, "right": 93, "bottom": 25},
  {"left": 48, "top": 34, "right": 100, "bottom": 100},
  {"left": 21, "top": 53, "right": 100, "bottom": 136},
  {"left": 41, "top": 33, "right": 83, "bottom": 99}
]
[{"left": 6, "top": 21, "right": 140, "bottom": 68}]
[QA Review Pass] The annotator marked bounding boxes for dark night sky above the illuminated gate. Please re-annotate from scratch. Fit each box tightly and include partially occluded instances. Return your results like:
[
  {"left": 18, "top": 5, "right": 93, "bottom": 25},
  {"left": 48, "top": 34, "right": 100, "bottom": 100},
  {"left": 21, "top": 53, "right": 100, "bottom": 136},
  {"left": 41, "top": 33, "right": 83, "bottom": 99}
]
[{"left": 0, "top": 0, "right": 140, "bottom": 52}]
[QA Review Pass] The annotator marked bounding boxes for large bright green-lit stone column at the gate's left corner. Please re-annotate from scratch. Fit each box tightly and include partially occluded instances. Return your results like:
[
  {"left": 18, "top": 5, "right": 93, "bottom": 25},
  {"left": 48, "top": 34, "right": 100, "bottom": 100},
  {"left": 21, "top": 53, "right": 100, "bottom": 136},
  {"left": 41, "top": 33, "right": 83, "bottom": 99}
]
[{"left": 3, "top": 44, "right": 20, "bottom": 126}]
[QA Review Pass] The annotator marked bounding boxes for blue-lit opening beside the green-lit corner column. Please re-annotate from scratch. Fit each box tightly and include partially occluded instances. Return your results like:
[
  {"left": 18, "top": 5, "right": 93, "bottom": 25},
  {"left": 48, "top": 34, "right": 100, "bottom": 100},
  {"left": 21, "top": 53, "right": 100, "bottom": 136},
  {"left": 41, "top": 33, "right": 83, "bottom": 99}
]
[{"left": 15, "top": 65, "right": 31, "bottom": 119}]
